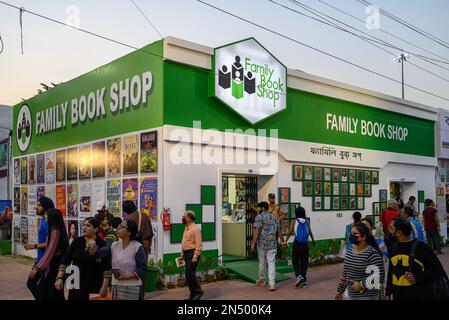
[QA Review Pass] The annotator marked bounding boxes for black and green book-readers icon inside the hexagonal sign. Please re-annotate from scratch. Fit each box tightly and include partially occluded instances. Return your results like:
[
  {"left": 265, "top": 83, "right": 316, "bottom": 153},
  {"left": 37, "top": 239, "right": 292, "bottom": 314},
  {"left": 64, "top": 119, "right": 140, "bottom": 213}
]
[{"left": 218, "top": 56, "right": 256, "bottom": 99}]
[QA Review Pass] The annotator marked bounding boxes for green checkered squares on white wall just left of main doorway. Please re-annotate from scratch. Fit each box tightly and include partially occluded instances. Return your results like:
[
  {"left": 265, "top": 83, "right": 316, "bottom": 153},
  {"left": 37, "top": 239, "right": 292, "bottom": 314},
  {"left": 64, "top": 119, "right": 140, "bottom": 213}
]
[{"left": 170, "top": 185, "right": 216, "bottom": 243}]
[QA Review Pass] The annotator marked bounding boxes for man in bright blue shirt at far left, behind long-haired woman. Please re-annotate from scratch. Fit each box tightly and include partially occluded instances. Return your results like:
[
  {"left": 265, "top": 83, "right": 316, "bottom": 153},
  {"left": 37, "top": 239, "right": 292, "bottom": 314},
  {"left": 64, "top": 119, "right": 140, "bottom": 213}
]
[{"left": 24, "top": 196, "right": 55, "bottom": 300}]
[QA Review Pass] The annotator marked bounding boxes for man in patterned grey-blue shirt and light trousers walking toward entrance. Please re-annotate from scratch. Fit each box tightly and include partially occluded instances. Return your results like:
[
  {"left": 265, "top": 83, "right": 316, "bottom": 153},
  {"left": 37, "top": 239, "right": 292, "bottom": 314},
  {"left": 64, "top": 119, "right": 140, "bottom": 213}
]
[{"left": 251, "top": 201, "right": 284, "bottom": 291}]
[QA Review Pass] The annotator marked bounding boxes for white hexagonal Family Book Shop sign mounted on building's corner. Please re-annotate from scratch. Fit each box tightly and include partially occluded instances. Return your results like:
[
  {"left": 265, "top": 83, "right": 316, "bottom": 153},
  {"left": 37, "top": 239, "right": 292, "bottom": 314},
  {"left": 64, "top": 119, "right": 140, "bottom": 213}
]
[{"left": 214, "top": 38, "right": 287, "bottom": 124}]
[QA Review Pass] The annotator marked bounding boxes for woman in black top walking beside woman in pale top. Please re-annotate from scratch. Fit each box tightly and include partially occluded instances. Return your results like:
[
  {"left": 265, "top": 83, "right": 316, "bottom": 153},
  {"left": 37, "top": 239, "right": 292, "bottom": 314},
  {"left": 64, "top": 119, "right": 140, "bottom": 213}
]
[{"left": 55, "top": 218, "right": 111, "bottom": 300}]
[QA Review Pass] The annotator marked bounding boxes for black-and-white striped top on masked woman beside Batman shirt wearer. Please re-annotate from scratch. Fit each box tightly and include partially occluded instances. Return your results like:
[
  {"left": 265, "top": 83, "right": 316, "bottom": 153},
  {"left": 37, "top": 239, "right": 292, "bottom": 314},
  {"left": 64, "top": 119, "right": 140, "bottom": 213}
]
[{"left": 337, "top": 246, "right": 385, "bottom": 298}]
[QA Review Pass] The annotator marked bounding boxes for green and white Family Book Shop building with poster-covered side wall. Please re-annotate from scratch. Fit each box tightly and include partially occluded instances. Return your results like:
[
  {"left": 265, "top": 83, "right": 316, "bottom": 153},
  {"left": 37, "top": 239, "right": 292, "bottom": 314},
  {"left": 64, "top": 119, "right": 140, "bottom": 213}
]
[{"left": 13, "top": 38, "right": 438, "bottom": 262}]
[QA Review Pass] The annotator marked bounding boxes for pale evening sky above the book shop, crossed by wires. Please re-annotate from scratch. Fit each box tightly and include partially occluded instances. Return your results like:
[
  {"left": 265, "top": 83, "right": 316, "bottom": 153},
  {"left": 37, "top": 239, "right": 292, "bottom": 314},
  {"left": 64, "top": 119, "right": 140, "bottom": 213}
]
[{"left": 0, "top": 0, "right": 449, "bottom": 109}]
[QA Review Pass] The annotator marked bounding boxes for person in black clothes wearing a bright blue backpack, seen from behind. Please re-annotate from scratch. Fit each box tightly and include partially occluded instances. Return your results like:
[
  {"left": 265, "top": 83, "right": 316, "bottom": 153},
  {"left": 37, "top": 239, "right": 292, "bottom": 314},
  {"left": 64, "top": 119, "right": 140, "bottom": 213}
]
[{"left": 284, "top": 207, "right": 315, "bottom": 288}]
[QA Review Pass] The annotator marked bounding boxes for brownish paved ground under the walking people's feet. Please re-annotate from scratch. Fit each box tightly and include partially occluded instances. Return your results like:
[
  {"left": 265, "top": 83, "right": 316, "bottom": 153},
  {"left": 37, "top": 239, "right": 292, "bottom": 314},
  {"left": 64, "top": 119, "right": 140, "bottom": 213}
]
[{"left": 0, "top": 248, "right": 449, "bottom": 300}]
